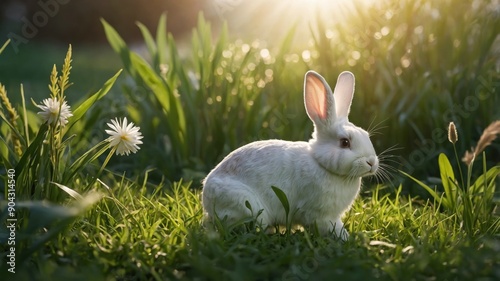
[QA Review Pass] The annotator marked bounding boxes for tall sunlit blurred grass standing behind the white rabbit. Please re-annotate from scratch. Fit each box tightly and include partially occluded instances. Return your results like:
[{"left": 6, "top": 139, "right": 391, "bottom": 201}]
[{"left": 104, "top": 0, "right": 500, "bottom": 184}]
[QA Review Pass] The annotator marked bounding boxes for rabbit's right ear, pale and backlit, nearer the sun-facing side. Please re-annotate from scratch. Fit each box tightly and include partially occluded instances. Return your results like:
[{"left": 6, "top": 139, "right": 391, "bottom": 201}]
[{"left": 333, "top": 71, "right": 354, "bottom": 119}]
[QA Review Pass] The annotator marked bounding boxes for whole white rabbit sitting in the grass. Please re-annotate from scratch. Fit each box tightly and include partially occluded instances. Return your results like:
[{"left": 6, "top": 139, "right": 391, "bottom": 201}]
[{"left": 202, "top": 71, "right": 379, "bottom": 240}]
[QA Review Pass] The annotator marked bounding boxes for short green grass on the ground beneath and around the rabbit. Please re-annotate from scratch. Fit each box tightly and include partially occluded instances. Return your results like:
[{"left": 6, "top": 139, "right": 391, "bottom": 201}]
[{"left": 2, "top": 182, "right": 500, "bottom": 280}]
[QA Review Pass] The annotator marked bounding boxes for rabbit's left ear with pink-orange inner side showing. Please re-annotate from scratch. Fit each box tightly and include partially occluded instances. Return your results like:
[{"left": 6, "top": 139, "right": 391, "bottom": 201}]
[{"left": 304, "top": 71, "right": 336, "bottom": 126}]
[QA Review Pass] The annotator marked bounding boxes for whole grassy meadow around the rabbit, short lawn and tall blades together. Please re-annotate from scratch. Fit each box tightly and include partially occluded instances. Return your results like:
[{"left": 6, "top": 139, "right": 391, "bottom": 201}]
[{"left": 0, "top": 0, "right": 500, "bottom": 280}]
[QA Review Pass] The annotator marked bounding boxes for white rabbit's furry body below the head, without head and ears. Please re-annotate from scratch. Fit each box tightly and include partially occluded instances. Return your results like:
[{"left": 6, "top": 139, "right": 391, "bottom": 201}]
[{"left": 203, "top": 140, "right": 361, "bottom": 234}]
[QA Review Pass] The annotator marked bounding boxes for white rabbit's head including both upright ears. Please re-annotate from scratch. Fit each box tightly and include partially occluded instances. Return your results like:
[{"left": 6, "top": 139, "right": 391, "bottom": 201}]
[{"left": 304, "top": 71, "right": 379, "bottom": 179}]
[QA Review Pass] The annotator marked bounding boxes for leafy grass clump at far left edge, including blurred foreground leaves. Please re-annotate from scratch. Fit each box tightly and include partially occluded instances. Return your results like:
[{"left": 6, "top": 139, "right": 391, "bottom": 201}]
[{"left": 0, "top": 42, "right": 125, "bottom": 264}]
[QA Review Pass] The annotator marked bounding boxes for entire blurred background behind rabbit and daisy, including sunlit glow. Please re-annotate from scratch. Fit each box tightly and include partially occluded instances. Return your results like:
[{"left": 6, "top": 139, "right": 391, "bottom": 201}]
[{"left": 0, "top": 0, "right": 500, "bottom": 189}]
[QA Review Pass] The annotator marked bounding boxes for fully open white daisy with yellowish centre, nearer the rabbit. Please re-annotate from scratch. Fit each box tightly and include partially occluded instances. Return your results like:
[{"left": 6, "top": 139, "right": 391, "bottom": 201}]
[{"left": 106, "top": 117, "right": 143, "bottom": 155}]
